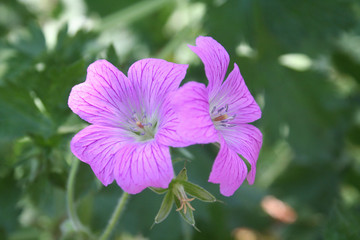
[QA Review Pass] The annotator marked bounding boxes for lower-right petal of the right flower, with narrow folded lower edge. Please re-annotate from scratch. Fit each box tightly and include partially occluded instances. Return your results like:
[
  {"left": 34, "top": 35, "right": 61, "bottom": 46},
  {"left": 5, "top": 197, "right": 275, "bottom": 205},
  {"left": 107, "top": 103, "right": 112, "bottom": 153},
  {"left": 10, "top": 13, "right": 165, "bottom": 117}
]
[{"left": 220, "top": 124, "right": 263, "bottom": 184}]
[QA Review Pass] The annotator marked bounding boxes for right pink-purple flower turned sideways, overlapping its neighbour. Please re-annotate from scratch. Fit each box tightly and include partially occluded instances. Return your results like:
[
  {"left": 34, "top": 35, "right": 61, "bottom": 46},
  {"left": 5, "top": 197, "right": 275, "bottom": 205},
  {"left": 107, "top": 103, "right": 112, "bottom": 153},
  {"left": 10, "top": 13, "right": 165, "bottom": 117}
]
[{"left": 173, "top": 36, "right": 262, "bottom": 196}]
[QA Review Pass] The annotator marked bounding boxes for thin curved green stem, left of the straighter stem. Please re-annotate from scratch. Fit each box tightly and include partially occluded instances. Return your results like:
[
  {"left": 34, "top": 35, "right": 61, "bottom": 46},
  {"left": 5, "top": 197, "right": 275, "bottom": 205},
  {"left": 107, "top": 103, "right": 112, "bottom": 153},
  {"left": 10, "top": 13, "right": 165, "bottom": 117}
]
[{"left": 66, "top": 158, "right": 83, "bottom": 231}]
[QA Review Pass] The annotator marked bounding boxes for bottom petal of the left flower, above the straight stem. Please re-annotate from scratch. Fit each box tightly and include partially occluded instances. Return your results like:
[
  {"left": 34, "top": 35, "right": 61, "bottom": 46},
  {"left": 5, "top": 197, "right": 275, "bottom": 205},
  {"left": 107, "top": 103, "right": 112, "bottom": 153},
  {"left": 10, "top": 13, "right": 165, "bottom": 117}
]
[{"left": 114, "top": 141, "right": 174, "bottom": 194}]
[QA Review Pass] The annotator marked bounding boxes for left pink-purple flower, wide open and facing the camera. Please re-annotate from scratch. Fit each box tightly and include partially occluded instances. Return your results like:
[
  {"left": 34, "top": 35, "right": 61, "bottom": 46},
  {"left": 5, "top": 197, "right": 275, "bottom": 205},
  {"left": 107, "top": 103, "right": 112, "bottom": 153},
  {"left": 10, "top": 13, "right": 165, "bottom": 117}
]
[{"left": 68, "top": 59, "right": 188, "bottom": 194}]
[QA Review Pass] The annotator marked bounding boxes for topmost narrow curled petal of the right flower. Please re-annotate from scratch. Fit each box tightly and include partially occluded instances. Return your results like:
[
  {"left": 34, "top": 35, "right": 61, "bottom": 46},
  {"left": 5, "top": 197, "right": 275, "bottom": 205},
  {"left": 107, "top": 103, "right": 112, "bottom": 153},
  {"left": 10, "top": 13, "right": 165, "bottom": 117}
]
[{"left": 189, "top": 36, "right": 229, "bottom": 99}]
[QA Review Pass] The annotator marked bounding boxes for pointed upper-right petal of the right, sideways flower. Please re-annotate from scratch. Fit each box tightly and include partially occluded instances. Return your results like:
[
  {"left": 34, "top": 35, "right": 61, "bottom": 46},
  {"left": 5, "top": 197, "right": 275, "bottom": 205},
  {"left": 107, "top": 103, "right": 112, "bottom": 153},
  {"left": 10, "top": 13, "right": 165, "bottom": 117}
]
[{"left": 210, "top": 64, "right": 261, "bottom": 124}]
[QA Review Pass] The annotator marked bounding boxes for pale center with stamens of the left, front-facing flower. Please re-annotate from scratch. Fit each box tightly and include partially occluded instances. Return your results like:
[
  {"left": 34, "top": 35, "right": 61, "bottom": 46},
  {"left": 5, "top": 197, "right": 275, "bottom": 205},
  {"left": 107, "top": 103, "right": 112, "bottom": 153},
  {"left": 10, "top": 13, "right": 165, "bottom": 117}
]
[{"left": 127, "top": 112, "right": 157, "bottom": 141}]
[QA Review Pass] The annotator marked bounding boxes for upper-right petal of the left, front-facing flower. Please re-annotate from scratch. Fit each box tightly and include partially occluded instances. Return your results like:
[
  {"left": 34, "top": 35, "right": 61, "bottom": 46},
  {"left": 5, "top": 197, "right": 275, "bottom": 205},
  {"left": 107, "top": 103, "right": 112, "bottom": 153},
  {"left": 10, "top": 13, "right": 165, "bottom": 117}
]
[{"left": 128, "top": 58, "right": 188, "bottom": 114}]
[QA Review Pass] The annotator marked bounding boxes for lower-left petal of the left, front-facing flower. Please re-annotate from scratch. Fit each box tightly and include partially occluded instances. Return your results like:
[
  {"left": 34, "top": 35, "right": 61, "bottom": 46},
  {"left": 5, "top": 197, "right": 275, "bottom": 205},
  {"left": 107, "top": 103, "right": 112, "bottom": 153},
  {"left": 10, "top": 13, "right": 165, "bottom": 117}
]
[{"left": 70, "top": 125, "right": 133, "bottom": 186}]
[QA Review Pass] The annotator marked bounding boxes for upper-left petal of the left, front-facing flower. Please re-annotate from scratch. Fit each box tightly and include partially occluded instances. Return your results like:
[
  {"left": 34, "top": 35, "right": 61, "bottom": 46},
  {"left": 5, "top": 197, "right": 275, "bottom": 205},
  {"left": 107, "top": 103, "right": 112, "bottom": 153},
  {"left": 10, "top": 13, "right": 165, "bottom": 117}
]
[{"left": 68, "top": 60, "right": 131, "bottom": 126}]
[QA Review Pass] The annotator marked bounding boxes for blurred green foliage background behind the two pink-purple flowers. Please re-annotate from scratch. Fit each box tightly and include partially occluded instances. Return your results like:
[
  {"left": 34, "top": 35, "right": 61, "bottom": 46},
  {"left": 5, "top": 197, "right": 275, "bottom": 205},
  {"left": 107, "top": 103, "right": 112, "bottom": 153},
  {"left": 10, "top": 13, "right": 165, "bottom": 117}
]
[{"left": 0, "top": 0, "right": 360, "bottom": 240}]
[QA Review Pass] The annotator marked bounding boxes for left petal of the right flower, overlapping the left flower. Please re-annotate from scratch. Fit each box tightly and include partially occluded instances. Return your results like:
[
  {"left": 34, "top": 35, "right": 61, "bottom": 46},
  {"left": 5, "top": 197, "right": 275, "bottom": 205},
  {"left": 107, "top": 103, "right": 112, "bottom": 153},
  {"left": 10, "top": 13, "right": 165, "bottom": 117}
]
[{"left": 172, "top": 82, "right": 217, "bottom": 143}]
